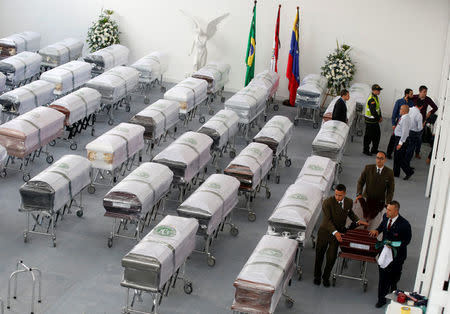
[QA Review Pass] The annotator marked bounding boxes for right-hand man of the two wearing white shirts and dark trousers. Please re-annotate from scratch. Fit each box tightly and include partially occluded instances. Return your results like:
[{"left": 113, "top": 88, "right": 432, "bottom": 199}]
[{"left": 406, "top": 99, "right": 424, "bottom": 164}]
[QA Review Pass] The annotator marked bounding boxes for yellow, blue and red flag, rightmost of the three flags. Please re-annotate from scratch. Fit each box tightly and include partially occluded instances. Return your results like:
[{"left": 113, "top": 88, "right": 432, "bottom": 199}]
[{"left": 286, "top": 7, "right": 300, "bottom": 106}]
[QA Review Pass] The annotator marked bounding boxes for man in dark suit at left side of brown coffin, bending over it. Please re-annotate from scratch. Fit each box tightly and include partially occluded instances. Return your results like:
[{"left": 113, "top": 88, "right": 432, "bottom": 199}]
[{"left": 314, "top": 184, "right": 367, "bottom": 287}]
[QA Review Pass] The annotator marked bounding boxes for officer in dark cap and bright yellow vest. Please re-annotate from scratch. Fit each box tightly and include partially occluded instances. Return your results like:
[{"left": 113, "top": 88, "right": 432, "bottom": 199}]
[{"left": 363, "top": 84, "right": 383, "bottom": 156}]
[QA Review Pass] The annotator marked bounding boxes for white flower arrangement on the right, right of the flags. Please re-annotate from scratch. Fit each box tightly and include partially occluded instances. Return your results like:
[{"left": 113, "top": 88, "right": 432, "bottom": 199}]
[{"left": 321, "top": 43, "right": 356, "bottom": 94}]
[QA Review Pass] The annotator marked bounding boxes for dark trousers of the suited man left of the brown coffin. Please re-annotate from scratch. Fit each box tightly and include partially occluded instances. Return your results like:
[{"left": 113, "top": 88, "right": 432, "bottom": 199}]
[{"left": 314, "top": 229, "right": 339, "bottom": 280}]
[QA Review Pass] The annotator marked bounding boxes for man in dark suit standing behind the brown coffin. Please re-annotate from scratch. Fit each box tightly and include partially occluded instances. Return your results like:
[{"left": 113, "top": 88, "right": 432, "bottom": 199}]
[{"left": 356, "top": 151, "right": 395, "bottom": 224}]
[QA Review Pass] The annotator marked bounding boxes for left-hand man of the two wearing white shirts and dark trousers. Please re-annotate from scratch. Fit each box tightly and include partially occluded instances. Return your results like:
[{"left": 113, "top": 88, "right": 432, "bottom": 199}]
[{"left": 393, "top": 105, "right": 414, "bottom": 180}]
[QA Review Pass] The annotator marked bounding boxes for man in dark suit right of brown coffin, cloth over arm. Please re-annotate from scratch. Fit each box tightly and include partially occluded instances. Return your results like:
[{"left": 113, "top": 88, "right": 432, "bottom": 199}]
[{"left": 370, "top": 201, "right": 411, "bottom": 308}]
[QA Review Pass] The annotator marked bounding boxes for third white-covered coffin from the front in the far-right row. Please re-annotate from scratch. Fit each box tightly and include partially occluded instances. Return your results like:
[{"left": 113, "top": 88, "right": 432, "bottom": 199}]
[{"left": 295, "top": 156, "right": 336, "bottom": 194}]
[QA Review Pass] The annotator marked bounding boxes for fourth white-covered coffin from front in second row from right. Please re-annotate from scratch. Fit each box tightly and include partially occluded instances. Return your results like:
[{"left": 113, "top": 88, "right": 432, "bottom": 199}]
[{"left": 253, "top": 116, "right": 294, "bottom": 156}]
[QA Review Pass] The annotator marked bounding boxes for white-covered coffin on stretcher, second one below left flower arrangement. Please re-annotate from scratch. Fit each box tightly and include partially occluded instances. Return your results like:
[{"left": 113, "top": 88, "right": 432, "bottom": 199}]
[{"left": 85, "top": 66, "right": 139, "bottom": 125}]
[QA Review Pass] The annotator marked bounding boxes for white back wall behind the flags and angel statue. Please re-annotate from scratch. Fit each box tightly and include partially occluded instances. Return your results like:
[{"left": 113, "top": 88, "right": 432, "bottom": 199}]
[{"left": 0, "top": 0, "right": 449, "bottom": 113}]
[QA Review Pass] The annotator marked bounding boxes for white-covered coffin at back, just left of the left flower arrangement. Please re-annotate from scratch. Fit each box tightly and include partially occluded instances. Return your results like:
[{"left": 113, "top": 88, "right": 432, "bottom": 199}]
[{"left": 39, "top": 38, "right": 84, "bottom": 68}]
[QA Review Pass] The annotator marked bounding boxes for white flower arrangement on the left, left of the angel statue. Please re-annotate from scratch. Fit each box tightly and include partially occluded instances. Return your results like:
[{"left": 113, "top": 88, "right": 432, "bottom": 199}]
[{"left": 86, "top": 10, "right": 120, "bottom": 52}]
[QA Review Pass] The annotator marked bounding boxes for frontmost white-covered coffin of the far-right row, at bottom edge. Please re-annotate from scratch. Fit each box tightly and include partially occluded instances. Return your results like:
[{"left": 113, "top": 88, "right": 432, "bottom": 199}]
[{"left": 231, "top": 235, "right": 297, "bottom": 314}]
